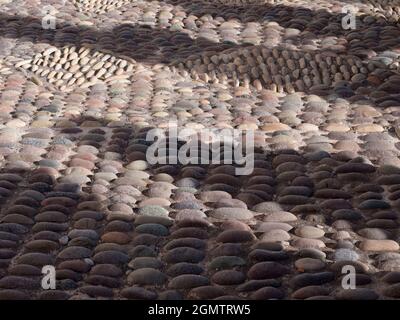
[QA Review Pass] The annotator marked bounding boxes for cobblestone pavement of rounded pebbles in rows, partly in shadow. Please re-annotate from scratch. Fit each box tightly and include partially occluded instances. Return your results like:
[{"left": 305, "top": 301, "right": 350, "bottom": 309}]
[{"left": 0, "top": 0, "right": 400, "bottom": 300}]
